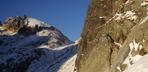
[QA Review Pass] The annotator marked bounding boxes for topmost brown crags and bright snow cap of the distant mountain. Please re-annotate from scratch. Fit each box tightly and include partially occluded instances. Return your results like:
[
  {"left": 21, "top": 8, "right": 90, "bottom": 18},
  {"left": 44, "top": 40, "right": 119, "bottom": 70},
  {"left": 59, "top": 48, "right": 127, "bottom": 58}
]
[{"left": 2, "top": 15, "right": 51, "bottom": 32}]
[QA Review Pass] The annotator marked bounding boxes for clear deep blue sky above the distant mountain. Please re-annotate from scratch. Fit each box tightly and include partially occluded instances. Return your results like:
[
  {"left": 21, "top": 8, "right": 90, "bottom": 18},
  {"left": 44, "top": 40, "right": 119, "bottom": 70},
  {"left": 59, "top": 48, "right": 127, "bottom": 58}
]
[{"left": 0, "top": 0, "right": 89, "bottom": 40}]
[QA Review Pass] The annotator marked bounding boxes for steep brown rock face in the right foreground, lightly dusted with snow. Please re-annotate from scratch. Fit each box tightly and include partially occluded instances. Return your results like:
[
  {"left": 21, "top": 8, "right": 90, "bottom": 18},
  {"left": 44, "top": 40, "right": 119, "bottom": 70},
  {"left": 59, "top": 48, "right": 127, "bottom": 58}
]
[{"left": 76, "top": 0, "right": 148, "bottom": 72}]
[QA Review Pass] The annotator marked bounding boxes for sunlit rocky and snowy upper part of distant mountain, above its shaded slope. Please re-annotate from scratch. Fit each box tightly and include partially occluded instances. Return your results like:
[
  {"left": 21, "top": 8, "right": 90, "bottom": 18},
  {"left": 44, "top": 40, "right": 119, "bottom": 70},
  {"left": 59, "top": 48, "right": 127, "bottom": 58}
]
[{"left": 0, "top": 15, "right": 72, "bottom": 47}]
